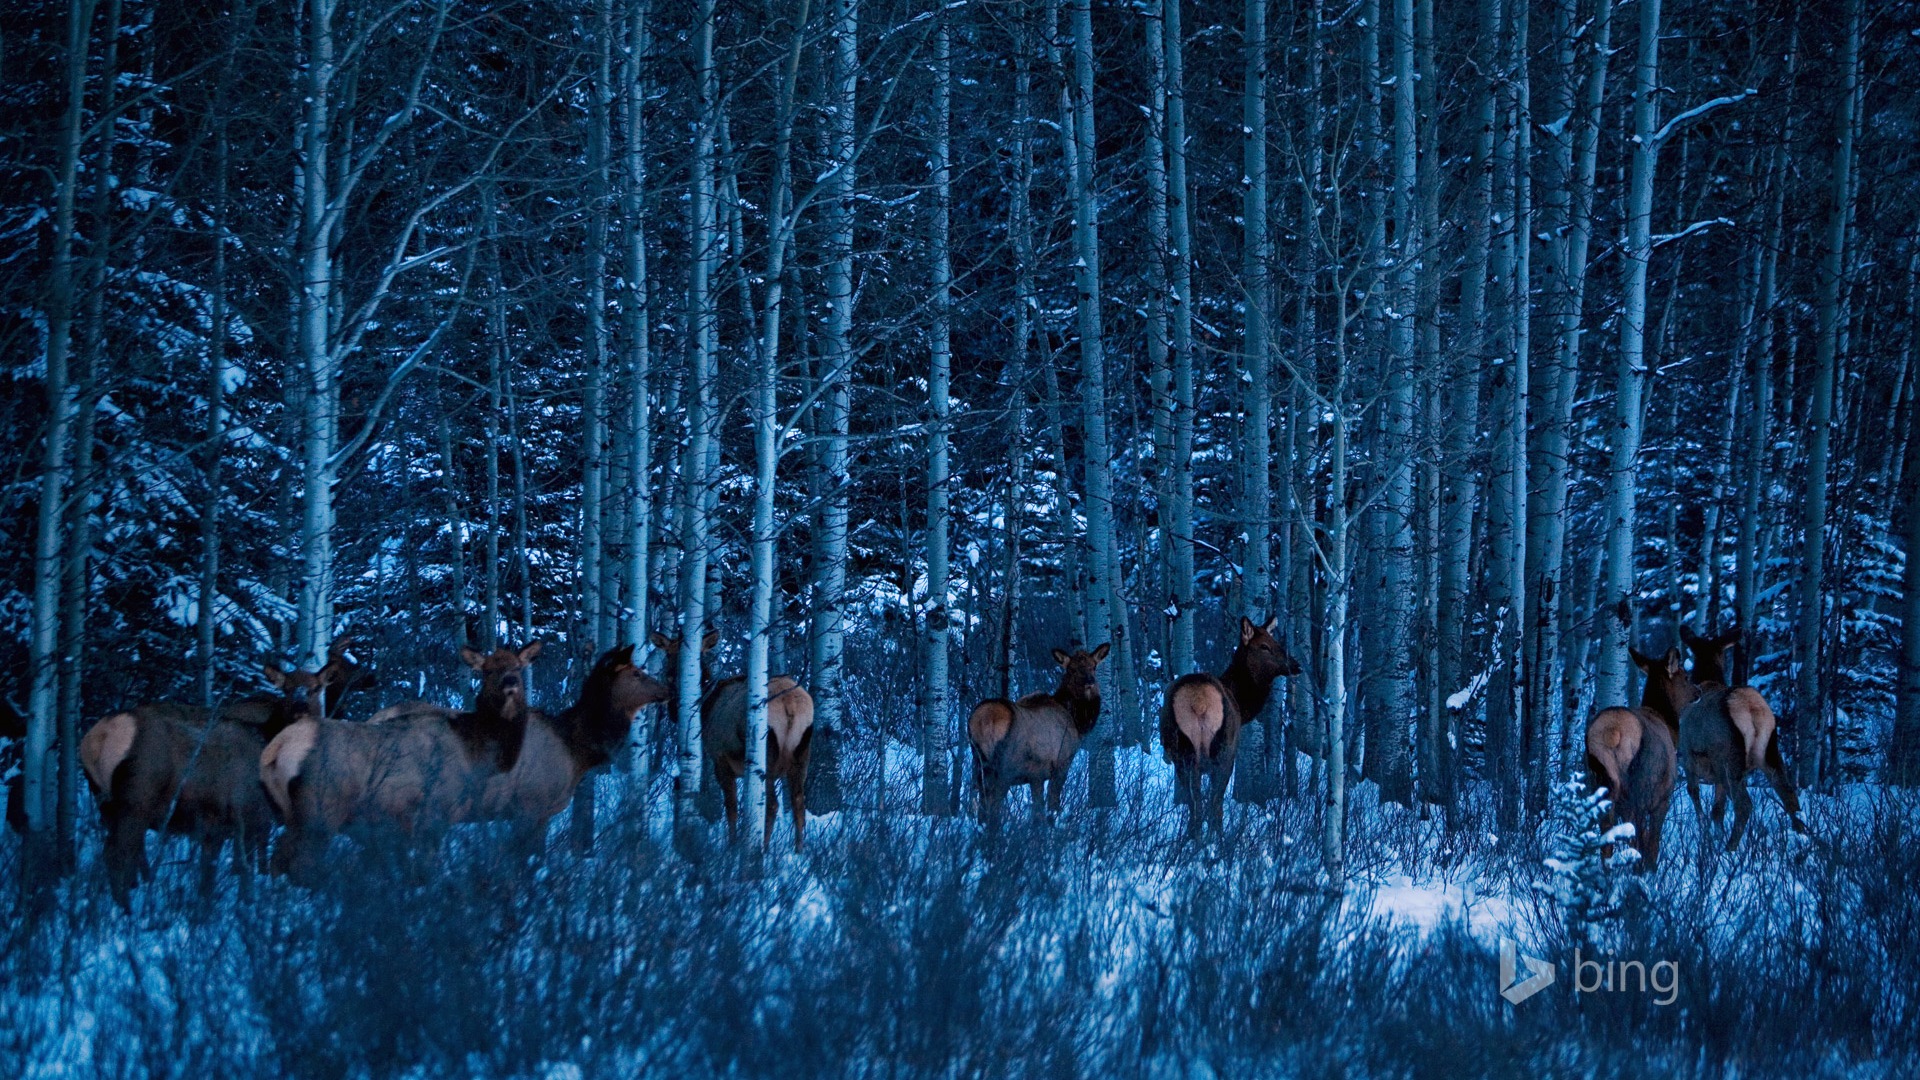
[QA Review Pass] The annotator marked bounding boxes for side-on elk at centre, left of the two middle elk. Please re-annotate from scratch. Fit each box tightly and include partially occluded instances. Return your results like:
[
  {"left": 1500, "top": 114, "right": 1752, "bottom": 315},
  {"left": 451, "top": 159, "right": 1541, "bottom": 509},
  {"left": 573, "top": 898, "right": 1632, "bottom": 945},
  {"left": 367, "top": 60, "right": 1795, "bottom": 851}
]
[{"left": 966, "top": 646, "right": 1108, "bottom": 822}]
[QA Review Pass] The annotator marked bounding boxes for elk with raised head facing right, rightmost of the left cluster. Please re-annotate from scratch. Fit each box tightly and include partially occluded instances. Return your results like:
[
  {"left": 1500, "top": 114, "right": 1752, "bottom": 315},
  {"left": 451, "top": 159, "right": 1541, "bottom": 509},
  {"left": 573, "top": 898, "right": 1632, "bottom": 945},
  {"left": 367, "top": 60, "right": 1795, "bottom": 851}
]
[{"left": 474, "top": 646, "right": 666, "bottom": 847}]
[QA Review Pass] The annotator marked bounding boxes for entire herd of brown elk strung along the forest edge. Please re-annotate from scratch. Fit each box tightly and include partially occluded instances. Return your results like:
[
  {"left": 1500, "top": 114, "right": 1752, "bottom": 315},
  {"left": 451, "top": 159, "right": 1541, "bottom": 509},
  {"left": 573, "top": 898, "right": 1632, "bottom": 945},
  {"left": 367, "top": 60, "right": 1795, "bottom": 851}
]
[{"left": 22, "top": 591, "right": 1807, "bottom": 905}]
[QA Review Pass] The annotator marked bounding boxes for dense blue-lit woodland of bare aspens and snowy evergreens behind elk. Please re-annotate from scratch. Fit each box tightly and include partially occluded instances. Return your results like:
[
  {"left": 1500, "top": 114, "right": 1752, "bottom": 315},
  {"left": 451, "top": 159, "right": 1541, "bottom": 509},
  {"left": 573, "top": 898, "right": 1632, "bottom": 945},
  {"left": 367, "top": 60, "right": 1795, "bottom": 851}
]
[{"left": 0, "top": 0, "right": 1920, "bottom": 884}]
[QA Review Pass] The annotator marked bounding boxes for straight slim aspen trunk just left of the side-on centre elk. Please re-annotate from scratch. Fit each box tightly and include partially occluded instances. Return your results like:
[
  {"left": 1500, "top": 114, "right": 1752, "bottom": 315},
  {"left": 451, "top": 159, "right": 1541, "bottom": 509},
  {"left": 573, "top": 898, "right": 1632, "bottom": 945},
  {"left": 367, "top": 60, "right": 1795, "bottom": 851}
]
[{"left": 920, "top": 8, "right": 952, "bottom": 815}]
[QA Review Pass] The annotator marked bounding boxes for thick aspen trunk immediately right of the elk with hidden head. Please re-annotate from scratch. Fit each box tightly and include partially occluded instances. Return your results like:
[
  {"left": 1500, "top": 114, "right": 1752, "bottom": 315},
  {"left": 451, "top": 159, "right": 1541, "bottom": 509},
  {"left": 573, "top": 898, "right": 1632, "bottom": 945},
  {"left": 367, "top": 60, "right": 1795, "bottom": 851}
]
[{"left": 812, "top": 0, "right": 860, "bottom": 786}]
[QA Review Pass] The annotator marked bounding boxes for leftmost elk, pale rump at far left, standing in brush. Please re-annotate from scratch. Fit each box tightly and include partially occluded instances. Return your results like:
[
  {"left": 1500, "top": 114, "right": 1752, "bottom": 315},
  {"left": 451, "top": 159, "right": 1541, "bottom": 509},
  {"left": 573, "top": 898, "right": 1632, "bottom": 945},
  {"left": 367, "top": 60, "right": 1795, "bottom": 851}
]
[{"left": 79, "top": 650, "right": 353, "bottom": 907}]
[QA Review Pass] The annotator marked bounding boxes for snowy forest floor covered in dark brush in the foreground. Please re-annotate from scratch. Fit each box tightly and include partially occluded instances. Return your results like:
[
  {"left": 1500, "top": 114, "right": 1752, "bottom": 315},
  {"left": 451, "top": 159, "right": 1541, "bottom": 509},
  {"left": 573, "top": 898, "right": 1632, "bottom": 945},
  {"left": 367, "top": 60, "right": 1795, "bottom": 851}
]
[{"left": 0, "top": 751, "right": 1920, "bottom": 1076}]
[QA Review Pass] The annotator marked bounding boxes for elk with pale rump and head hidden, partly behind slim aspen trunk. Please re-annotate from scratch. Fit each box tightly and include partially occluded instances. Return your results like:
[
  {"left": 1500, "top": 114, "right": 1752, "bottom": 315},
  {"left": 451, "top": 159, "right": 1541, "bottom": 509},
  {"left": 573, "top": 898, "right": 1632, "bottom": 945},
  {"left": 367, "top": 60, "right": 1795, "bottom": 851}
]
[{"left": 701, "top": 675, "right": 814, "bottom": 851}]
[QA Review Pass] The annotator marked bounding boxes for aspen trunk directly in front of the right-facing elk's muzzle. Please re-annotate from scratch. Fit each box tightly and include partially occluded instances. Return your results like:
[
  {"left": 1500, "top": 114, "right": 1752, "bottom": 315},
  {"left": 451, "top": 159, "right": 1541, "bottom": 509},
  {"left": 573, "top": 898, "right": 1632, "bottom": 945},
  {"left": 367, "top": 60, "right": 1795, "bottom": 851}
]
[{"left": 674, "top": 0, "right": 720, "bottom": 842}]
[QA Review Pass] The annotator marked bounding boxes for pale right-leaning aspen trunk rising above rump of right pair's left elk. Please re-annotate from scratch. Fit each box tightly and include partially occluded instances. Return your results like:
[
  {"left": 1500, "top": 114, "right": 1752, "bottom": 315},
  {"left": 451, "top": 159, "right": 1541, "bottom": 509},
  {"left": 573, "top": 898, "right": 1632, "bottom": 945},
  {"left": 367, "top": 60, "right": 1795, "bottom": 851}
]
[{"left": 1594, "top": 0, "right": 1661, "bottom": 707}]
